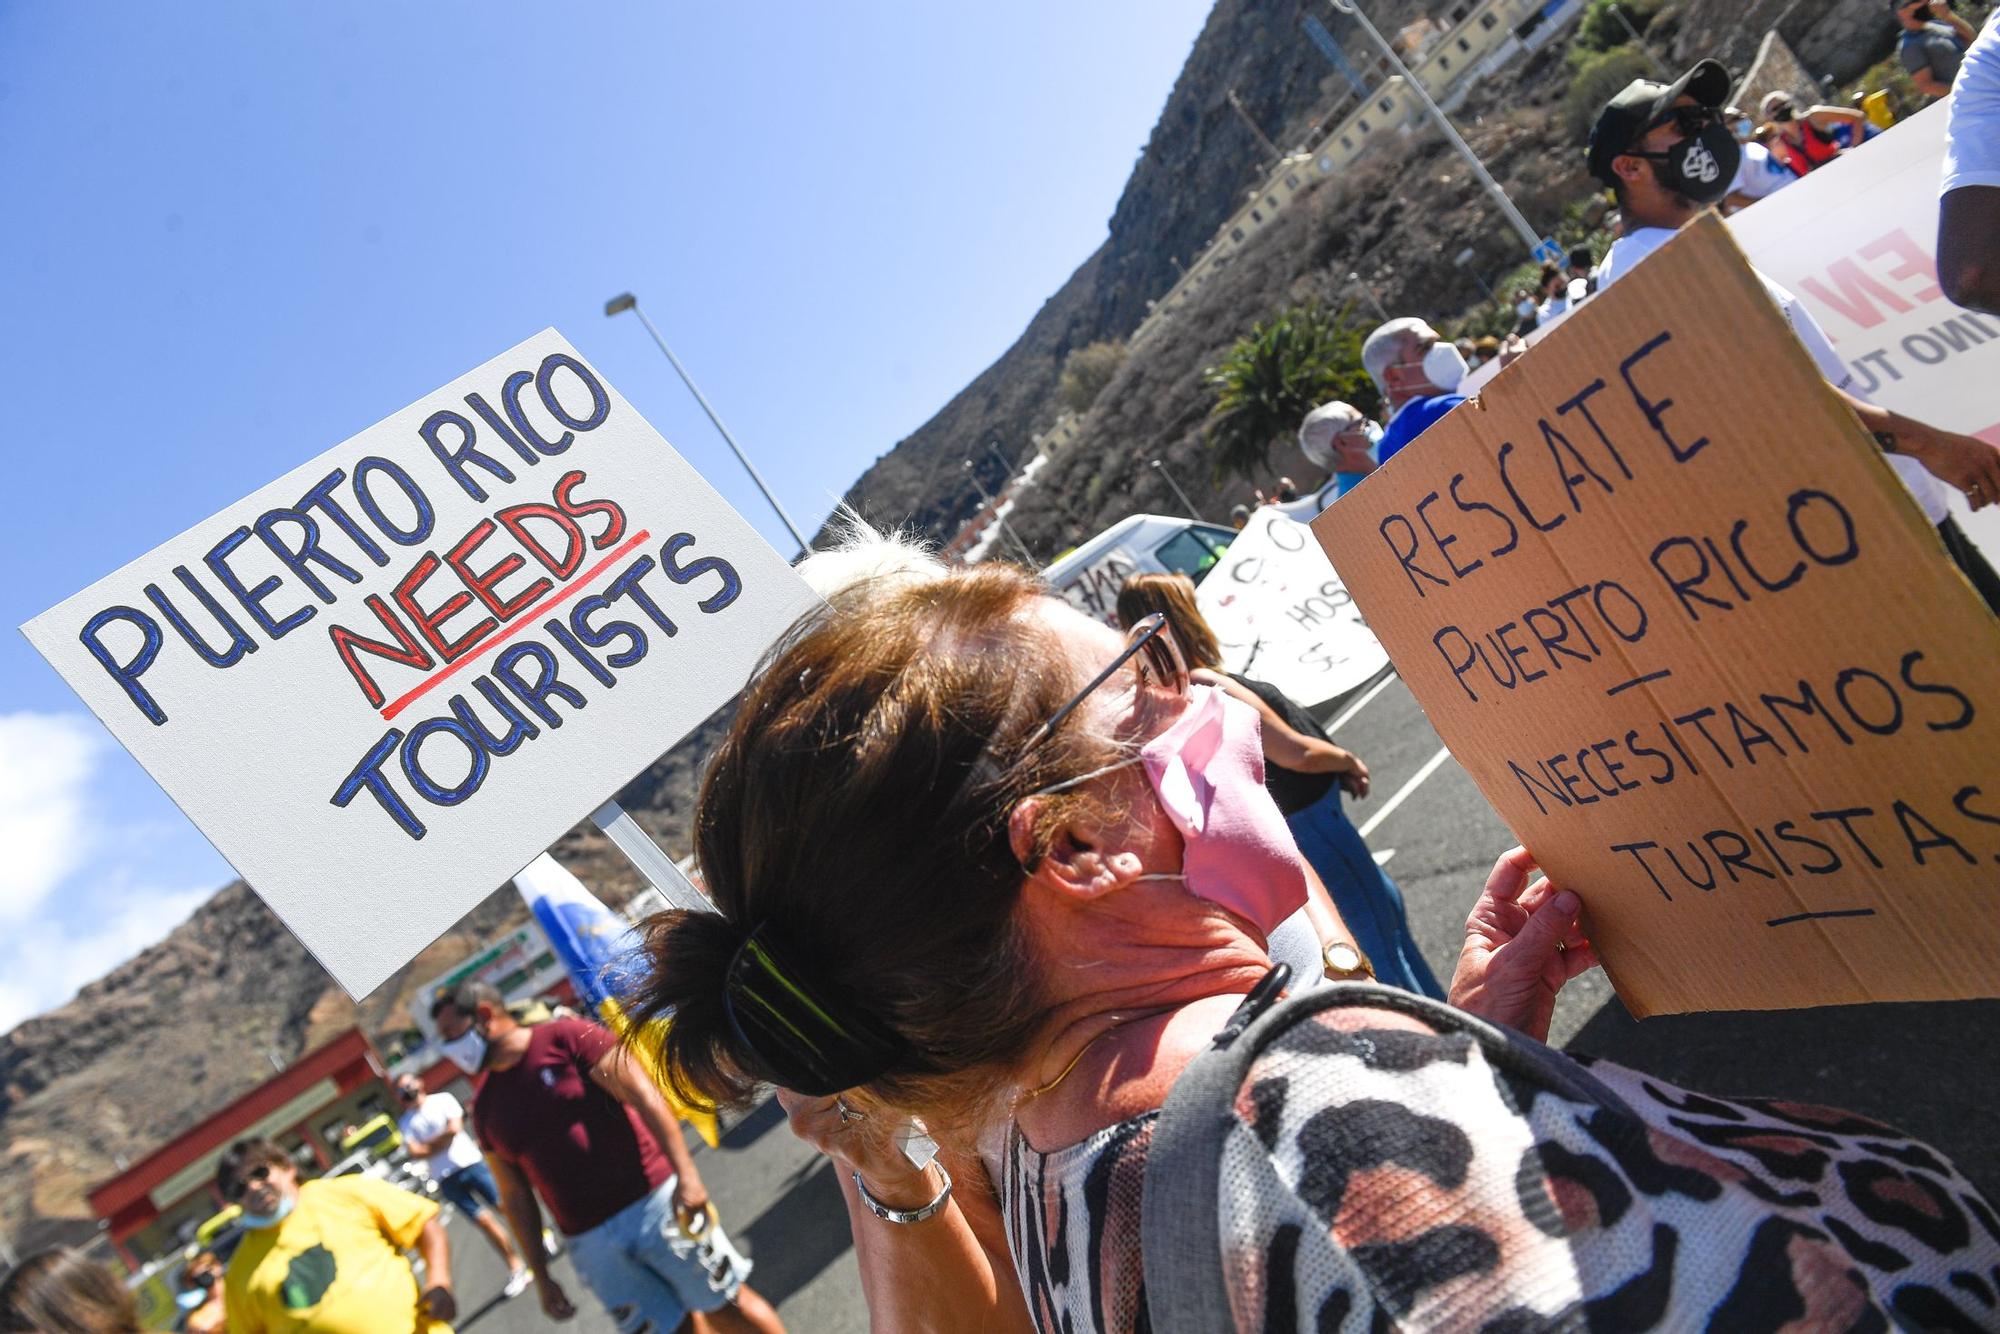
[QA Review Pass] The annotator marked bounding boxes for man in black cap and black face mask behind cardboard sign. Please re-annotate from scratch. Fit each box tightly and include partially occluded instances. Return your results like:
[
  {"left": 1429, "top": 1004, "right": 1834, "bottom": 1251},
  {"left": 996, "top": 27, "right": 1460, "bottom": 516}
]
[{"left": 1588, "top": 60, "right": 2000, "bottom": 614}]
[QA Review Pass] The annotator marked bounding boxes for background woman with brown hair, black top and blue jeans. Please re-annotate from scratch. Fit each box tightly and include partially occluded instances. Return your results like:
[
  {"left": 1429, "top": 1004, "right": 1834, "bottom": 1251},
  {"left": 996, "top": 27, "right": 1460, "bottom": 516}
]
[{"left": 1118, "top": 574, "right": 1444, "bottom": 1000}]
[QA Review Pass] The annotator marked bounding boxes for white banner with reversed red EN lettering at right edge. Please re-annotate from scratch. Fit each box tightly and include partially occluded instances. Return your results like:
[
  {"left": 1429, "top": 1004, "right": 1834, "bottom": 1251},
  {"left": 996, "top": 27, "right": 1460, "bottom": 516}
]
[{"left": 1730, "top": 102, "right": 2000, "bottom": 562}]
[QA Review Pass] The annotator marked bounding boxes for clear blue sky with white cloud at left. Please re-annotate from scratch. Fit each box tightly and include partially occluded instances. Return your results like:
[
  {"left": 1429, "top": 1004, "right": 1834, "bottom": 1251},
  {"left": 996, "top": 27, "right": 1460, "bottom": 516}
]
[{"left": 0, "top": 0, "right": 1208, "bottom": 1030}]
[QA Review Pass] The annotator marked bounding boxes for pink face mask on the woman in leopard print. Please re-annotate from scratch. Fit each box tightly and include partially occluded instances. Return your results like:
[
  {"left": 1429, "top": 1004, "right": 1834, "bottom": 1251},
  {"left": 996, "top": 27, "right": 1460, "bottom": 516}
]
[{"left": 1138, "top": 686, "right": 1306, "bottom": 936}]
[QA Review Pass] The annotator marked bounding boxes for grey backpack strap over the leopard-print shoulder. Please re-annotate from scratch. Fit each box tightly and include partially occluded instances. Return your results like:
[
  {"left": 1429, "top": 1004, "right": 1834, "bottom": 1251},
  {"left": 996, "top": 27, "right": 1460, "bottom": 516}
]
[{"left": 1140, "top": 964, "right": 1638, "bottom": 1334}]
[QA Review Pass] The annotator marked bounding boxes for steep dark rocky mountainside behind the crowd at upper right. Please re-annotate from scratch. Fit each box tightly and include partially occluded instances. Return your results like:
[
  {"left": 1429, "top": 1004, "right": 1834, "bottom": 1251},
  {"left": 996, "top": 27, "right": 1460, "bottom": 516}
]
[{"left": 846, "top": 0, "right": 1894, "bottom": 558}]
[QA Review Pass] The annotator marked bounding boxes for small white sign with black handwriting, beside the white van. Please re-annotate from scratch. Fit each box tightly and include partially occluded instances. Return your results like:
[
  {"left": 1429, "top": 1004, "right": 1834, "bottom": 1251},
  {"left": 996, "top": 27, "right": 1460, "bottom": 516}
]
[{"left": 1194, "top": 508, "right": 1388, "bottom": 708}]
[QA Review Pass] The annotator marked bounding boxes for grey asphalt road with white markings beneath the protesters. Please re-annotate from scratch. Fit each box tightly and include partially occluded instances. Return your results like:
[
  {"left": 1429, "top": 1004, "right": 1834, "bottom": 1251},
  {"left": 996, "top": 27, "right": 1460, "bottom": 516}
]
[{"left": 452, "top": 678, "right": 2000, "bottom": 1334}]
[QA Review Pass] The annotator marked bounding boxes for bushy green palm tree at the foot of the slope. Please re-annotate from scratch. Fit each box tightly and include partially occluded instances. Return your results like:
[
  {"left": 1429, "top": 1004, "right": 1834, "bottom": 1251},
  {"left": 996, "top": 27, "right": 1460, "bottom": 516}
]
[{"left": 1202, "top": 300, "right": 1382, "bottom": 484}]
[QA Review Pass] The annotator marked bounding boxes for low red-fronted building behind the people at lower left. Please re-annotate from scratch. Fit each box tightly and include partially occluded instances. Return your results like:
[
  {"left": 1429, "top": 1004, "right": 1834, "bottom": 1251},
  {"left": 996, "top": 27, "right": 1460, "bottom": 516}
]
[{"left": 90, "top": 1028, "right": 396, "bottom": 1270}]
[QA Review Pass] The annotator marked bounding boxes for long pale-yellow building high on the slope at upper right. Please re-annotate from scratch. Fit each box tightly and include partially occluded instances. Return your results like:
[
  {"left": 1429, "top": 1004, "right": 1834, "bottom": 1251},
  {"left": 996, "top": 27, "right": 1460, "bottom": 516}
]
[{"left": 1130, "top": 0, "right": 1588, "bottom": 342}]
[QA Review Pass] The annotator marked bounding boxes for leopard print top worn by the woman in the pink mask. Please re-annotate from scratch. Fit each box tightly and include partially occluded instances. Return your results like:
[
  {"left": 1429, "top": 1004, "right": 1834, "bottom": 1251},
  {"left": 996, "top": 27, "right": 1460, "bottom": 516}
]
[{"left": 1002, "top": 1012, "right": 2000, "bottom": 1334}]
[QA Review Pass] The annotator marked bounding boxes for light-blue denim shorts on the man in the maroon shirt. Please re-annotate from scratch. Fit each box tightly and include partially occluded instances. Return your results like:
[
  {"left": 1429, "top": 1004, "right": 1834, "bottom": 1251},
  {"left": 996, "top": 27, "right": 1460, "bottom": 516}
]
[{"left": 568, "top": 1180, "right": 748, "bottom": 1334}]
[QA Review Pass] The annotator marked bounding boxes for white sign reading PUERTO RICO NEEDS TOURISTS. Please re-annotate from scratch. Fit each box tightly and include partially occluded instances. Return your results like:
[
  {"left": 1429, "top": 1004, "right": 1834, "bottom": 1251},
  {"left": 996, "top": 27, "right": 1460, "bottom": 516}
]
[{"left": 24, "top": 330, "right": 814, "bottom": 996}]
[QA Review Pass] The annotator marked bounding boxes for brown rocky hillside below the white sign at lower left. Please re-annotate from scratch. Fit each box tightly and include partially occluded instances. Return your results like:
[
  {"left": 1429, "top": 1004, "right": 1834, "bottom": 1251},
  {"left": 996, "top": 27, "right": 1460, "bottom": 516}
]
[{"left": 0, "top": 712, "right": 726, "bottom": 1252}]
